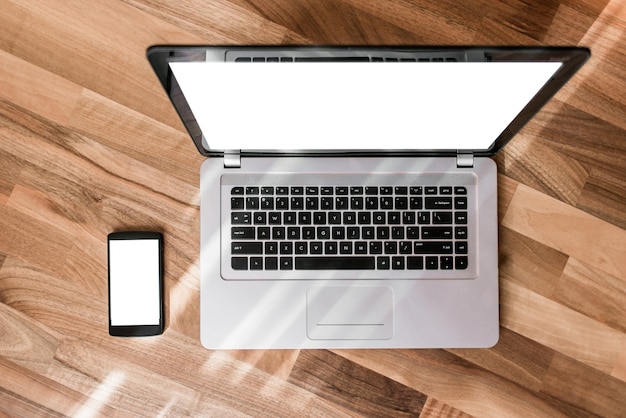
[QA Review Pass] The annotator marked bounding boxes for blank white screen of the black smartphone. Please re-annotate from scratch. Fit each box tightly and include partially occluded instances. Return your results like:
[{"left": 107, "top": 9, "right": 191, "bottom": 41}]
[{"left": 109, "top": 239, "right": 161, "bottom": 326}]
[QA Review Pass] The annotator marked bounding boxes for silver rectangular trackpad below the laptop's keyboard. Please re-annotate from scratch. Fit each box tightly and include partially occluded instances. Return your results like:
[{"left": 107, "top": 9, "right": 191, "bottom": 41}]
[{"left": 307, "top": 286, "right": 393, "bottom": 340}]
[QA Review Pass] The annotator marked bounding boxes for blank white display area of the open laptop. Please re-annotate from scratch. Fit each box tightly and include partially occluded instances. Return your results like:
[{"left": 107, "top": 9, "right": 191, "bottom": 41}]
[{"left": 170, "top": 62, "right": 561, "bottom": 151}]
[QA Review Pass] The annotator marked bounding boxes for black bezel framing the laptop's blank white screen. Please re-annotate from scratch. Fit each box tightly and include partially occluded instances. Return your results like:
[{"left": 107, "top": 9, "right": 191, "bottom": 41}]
[{"left": 147, "top": 45, "right": 590, "bottom": 157}]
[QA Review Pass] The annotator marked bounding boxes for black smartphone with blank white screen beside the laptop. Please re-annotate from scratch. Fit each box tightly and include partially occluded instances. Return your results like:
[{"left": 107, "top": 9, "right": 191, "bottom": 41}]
[{"left": 107, "top": 231, "right": 164, "bottom": 337}]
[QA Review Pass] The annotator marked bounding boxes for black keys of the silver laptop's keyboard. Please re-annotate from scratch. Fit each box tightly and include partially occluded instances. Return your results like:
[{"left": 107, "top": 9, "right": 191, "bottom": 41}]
[{"left": 230, "top": 185, "right": 470, "bottom": 271}]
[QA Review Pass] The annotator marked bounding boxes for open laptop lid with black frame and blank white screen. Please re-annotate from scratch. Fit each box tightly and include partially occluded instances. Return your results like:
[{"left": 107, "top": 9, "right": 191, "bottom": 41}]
[{"left": 148, "top": 46, "right": 590, "bottom": 156}]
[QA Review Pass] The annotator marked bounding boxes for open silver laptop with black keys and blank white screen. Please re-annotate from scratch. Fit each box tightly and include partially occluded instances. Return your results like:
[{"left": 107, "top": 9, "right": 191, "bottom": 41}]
[{"left": 147, "top": 46, "right": 590, "bottom": 349}]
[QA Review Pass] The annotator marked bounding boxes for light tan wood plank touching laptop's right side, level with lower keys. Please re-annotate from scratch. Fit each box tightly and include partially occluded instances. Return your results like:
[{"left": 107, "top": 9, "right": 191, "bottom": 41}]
[{"left": 502, "top": 185, "right": 626, "bottom": 277}]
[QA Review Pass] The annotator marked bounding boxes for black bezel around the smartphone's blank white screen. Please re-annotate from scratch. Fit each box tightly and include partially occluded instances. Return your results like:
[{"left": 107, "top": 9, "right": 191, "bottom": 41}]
[{"left": 107, "top": 231, "right": 165, "bottom": 337}]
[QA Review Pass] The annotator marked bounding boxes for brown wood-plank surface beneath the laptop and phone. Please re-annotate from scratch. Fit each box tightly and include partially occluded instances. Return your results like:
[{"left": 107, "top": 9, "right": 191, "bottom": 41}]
[{"left": 0, "top": 0, "right": 626, "bottom": 417}]
